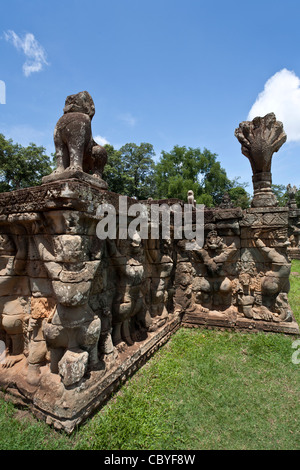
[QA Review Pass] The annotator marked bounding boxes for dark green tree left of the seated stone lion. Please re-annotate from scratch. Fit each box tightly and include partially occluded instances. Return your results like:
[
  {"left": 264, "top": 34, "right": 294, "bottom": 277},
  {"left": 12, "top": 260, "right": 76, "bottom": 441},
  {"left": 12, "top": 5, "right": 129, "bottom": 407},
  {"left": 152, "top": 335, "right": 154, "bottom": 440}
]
[{"left": 0, "top": 134, "right": 53, "bottom": 192}]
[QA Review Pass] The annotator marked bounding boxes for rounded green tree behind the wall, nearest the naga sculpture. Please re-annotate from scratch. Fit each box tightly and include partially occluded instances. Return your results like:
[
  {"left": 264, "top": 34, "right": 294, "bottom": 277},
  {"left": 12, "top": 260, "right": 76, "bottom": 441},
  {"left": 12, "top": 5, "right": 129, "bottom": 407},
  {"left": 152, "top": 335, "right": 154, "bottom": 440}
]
[{"left": 155, "top": 145, "right": 235, "bottom": 206}]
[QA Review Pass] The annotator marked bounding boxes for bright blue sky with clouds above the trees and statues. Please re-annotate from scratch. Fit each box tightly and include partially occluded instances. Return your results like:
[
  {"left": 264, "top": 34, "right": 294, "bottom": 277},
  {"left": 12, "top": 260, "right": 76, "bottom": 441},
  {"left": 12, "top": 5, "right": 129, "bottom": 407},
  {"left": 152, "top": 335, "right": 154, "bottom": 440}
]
[{"left": 0, "top": 0, "right": 300, "bottom": 192}]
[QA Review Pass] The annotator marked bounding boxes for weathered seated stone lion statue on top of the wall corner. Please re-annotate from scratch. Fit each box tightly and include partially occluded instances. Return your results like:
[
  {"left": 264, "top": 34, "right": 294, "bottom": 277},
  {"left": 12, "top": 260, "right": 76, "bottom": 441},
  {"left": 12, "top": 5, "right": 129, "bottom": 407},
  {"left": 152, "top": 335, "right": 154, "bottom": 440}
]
[{"left": 43, "top": 91, "right": 107, "bottom": 188}]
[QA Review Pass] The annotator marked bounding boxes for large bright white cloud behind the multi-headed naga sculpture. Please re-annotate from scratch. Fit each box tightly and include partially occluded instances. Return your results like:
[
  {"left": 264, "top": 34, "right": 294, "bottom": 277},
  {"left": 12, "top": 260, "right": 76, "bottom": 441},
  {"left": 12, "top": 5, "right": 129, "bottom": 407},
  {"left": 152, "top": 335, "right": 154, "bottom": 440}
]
[{"left": 248, "top": 69, "right": 300, "bottom": 142}]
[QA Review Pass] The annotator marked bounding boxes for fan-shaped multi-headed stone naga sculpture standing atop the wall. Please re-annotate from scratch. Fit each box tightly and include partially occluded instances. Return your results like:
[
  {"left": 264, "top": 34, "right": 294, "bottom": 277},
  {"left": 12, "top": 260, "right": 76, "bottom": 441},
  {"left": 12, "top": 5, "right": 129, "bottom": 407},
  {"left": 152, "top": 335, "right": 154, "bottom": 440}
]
[{"left": 235, "top": 113, "right": 287, "bottom": 207}]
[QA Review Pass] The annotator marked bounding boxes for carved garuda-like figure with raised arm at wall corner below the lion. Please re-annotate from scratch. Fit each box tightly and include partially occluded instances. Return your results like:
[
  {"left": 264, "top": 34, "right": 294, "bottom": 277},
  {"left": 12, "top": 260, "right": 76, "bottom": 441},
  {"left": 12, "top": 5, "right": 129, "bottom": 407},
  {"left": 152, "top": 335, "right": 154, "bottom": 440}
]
[{"left": 35, "top": 218, "right": 101, "bottom": 385}]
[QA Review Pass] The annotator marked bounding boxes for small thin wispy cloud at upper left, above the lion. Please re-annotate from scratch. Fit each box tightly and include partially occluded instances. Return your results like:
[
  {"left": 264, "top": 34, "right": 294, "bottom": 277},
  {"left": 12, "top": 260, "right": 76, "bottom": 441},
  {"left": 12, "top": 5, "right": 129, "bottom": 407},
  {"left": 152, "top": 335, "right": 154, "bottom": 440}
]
[{"left": 4, "top": 31, "right": 48, "bottom": 77}]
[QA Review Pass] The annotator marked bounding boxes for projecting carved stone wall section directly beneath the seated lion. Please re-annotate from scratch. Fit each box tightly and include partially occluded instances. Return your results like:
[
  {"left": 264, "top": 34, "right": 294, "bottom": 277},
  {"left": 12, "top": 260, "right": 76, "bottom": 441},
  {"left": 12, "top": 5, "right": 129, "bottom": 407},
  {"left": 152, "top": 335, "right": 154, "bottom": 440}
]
[{"left": 0, "top": 180, "right": 180, "bottom": 431}]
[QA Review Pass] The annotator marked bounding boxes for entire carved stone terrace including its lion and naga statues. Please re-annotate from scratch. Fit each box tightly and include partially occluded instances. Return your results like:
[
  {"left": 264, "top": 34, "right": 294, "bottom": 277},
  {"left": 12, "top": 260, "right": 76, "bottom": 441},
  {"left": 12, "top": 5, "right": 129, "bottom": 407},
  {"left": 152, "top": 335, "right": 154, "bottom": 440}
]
[{"left": 0, "top": 96, "right": 299, "bottom": 430}]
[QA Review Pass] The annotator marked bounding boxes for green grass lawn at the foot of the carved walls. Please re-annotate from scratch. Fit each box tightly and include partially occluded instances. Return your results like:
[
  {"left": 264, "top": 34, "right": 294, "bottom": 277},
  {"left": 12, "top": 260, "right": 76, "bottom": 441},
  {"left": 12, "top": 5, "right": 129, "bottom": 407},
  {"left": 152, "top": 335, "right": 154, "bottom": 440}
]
[{"left": 0, "top": 261, "right": 300, "bottom": 450}]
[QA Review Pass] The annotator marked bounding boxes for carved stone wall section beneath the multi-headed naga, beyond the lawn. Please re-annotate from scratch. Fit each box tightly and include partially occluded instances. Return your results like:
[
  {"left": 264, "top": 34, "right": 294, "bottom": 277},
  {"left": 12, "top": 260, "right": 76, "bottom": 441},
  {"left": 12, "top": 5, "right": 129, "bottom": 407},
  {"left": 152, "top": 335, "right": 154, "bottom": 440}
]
[{"left": 183, "top": 207, "right": 298, "bottom": 333}]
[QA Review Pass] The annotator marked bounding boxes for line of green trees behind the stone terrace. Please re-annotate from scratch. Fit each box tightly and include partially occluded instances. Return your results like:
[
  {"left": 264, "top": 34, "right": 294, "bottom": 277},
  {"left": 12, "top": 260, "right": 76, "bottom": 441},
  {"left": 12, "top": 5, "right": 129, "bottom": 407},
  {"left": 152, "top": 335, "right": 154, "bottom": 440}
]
[{"left": 0, "top": 134, "right": 284, "bottom": 209}]
